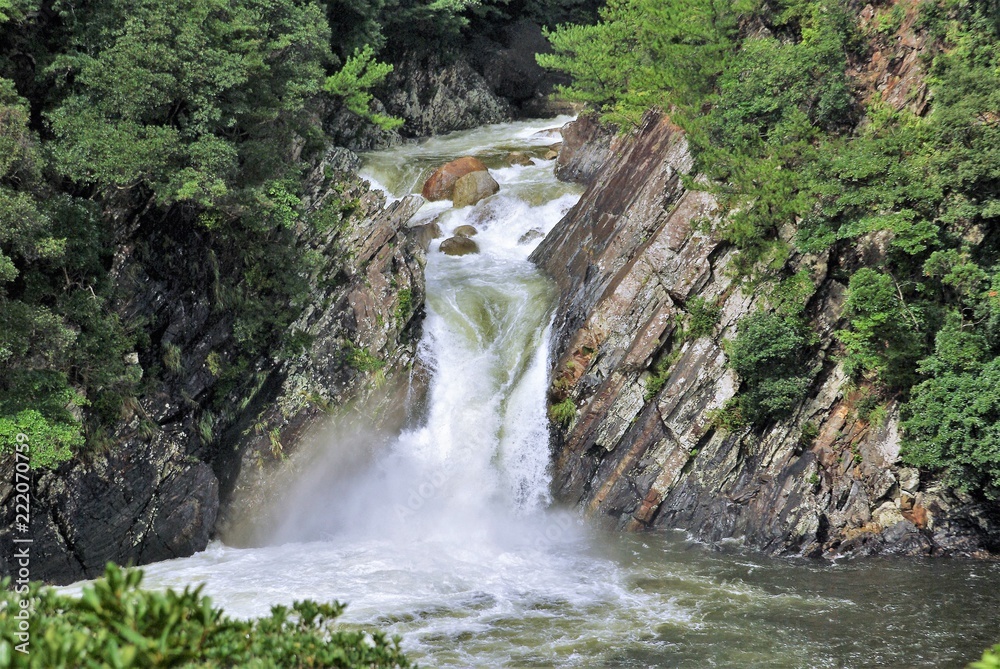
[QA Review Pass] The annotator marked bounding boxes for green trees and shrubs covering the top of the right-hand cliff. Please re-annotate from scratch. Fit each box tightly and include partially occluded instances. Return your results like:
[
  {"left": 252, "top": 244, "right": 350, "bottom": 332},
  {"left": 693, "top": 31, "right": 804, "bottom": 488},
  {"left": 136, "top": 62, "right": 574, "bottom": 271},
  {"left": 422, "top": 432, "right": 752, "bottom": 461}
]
[{"left": 539, "top": 0, "right": 1000, "bottom": 497}]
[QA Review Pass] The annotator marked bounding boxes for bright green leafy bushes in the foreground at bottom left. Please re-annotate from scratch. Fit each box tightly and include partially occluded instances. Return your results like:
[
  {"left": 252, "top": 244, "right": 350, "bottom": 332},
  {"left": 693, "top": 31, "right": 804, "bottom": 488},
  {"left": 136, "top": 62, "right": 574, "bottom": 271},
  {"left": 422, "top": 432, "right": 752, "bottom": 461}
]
[{"left": 0, "top": 564, "right": 410, "bottom": 669}]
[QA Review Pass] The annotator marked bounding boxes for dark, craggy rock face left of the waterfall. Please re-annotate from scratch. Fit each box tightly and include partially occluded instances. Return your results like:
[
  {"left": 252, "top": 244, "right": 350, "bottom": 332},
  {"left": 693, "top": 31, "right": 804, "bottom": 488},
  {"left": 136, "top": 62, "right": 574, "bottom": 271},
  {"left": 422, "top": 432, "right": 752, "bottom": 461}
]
[{"left": 0, "top": 155, "right": 424, "bottom": 583}]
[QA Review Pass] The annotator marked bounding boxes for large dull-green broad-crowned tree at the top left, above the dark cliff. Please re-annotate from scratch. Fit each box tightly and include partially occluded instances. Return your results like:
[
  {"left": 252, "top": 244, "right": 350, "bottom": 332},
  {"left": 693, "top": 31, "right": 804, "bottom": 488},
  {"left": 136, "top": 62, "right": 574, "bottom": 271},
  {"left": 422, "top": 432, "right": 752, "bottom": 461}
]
[{"left": 47, "top": 0, "right": 330, "bottom": 212}]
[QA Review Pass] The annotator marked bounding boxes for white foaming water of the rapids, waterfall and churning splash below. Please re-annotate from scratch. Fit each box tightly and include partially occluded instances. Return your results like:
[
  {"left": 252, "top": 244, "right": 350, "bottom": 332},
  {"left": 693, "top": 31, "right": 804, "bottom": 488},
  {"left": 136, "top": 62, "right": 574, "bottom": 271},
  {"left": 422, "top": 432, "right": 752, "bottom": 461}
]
[{"left": 131, "top": 119, "right": 696, "bottom": 666}]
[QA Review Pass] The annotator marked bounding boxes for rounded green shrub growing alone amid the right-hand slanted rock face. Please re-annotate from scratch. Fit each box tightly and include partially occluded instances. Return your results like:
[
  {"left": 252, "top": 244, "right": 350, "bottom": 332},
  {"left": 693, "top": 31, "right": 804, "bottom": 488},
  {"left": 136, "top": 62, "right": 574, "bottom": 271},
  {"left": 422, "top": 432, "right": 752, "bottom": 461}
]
[{"left": 726, "top": 311, "right": 812, "bottom": 424}]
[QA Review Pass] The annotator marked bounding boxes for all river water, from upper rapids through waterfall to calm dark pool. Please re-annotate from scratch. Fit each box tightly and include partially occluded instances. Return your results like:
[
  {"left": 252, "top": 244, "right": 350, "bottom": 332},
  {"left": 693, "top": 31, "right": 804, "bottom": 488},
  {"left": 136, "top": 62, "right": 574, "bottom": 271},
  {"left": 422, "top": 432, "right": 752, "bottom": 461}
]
[{"left": 97, "top": 119, "right": 1000, "bottom": 669}]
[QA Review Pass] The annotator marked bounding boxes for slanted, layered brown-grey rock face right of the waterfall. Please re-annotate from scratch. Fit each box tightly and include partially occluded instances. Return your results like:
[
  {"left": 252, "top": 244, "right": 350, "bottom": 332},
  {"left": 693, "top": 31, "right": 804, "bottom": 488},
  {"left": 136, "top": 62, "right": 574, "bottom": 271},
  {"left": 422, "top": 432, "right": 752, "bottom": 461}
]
[{"left": 532, "top": 115, "right": 1000, "bottom": 556}]
